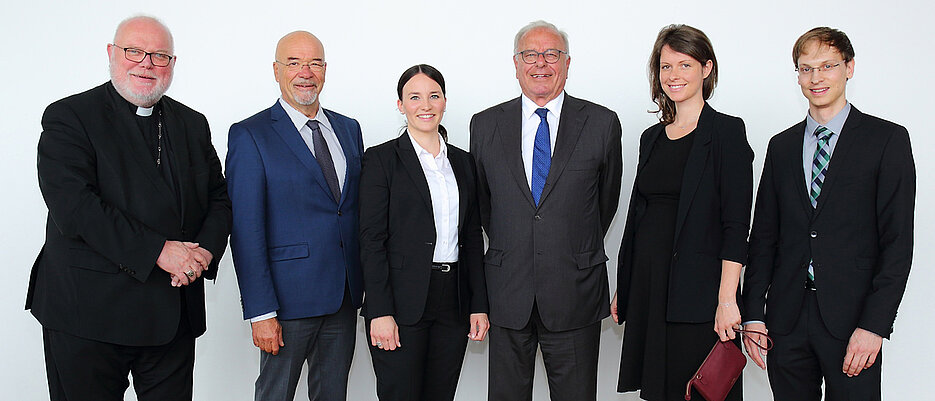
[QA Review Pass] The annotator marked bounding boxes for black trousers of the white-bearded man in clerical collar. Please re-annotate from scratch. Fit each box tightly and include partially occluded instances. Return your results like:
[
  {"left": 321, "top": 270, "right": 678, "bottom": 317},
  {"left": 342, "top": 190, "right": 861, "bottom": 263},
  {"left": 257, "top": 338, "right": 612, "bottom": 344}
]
[{"left": 42, "top": 322, "right": 195, "bottom": 401}]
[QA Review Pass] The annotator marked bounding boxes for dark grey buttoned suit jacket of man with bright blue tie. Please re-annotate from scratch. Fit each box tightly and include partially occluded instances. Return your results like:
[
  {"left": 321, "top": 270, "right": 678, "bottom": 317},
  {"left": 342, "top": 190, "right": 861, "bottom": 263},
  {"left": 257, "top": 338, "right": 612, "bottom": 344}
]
[{"left": 471, "top": 95, "right": 622, "bottom": 331}]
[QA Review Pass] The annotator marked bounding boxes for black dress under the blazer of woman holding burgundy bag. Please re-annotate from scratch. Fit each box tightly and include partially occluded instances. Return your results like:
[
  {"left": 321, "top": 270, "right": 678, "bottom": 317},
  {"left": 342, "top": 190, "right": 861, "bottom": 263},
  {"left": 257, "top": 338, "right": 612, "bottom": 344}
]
[{"left": 617, "top": 129, "right": 742, "bottom": 401}]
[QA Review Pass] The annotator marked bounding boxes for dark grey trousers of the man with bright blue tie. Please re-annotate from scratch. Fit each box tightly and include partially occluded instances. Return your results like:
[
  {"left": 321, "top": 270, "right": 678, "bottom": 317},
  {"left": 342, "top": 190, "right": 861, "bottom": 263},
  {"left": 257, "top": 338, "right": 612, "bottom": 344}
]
[{"left": 487, "top": 305, "right": 601, "bottom": 401}]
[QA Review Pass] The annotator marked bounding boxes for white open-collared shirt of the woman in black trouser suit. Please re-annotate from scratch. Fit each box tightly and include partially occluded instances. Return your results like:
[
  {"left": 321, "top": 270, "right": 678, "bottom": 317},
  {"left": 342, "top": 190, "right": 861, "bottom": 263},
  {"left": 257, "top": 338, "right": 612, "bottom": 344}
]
[{"left": 406, "top": 132, "right": 460, "bottom": 263}]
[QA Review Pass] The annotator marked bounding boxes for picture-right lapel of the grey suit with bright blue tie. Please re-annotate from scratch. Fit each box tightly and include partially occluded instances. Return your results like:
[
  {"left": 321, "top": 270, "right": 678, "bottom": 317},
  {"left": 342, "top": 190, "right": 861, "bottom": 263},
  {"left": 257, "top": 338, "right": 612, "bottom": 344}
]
[{"left": 539, "top": 94, "right": 588, "bottom": 206}]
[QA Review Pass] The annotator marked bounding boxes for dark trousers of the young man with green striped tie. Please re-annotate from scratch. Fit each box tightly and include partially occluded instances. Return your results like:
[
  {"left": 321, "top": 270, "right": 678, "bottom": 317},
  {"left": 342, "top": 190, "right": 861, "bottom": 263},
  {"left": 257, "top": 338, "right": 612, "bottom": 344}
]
[{"left": 767, "top": 291, "right": 883, "bottom": 401}]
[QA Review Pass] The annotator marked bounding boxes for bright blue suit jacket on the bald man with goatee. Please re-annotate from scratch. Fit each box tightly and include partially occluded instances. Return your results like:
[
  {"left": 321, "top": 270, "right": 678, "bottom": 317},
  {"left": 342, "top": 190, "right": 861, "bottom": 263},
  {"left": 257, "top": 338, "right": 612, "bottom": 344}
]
[{"left": 227, "top": 102, "right": 363, "bottom": 320}]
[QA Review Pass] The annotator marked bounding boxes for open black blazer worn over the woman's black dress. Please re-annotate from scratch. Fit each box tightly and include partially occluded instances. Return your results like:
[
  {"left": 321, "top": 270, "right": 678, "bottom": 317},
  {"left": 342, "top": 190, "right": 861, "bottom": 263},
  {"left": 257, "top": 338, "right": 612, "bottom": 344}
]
[{"left": 617, "top": 103, "right": 753, "bottom": 324}]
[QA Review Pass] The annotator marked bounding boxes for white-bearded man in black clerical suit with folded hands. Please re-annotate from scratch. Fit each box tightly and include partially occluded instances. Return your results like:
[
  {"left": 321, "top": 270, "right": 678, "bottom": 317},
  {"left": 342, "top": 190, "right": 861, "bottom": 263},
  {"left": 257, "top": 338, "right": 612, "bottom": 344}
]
[{"left": 26, "top": 17, "right": 231, "bottom": 401}]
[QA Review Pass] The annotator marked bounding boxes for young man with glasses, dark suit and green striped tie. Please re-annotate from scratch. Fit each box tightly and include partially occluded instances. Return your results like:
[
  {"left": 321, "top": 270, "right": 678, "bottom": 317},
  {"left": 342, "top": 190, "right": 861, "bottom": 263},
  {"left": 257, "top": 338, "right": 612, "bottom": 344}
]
[{"left": 743, "top": 27, "right": 916, "bottom": 401}]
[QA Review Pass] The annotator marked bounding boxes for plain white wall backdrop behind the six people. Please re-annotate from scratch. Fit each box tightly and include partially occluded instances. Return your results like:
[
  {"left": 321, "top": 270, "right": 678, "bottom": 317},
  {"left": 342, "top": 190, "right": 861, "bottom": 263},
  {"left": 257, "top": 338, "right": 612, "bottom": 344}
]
[{"left": 0, "top": 0, "right": 935, "bottom": 401}]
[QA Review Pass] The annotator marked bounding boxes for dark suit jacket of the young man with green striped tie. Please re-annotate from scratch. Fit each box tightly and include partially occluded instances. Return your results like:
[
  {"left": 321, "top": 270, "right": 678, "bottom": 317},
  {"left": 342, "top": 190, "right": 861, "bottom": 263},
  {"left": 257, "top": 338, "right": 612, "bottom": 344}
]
[{"left": 743, "top": 106, "right": 915, "bottom": 340}]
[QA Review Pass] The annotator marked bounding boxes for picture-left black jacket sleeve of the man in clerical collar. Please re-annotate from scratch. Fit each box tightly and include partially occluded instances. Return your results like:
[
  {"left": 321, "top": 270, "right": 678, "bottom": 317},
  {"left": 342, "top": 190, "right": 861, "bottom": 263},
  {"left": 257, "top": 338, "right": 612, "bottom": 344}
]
[{"left": 37, "top": 102, "right": 166, "bottom": 282}]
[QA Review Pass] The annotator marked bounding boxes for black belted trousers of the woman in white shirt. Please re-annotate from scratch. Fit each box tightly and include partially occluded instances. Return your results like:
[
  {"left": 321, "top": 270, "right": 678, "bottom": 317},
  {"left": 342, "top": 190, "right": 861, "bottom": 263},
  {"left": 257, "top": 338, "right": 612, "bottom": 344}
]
[{"left": 366, "top": 270, "right": 470, "bottom": 401}]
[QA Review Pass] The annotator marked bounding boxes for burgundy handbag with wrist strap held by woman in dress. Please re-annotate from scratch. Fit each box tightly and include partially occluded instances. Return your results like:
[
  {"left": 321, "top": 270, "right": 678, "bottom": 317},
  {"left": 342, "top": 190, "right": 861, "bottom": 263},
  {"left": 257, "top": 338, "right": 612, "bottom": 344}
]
[{"left": 685, "top": 329, "right": 773, "bottom": 401}]
